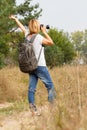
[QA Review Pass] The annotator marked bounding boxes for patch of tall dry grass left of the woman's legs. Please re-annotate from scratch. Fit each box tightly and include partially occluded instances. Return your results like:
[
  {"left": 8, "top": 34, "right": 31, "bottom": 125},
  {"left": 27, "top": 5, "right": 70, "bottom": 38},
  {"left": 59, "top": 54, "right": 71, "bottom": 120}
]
[{"left": 0, "top": 67, "right": 28, "bottom": 102}]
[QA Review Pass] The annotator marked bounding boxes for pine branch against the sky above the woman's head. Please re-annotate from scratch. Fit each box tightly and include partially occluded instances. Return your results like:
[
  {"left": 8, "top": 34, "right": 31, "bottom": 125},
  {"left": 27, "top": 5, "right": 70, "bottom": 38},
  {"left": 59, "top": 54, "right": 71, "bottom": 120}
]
[{"left": 16, "top": 0, "right": 42, "bottom": 26}]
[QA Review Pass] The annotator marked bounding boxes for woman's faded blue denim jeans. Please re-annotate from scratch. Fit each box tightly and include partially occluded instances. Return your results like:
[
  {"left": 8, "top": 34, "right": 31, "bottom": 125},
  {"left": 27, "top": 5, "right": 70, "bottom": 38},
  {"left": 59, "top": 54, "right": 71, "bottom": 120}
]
[{"left": 28, "top": 66, "right": 55, "bottom": 104}]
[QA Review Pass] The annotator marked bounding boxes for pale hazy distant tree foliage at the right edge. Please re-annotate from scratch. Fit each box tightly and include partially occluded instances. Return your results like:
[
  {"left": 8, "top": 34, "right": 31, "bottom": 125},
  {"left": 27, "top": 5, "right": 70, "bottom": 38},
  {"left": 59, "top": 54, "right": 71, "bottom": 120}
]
[{"left": 71, "top": 30, "right": 87, "bottom": 63}]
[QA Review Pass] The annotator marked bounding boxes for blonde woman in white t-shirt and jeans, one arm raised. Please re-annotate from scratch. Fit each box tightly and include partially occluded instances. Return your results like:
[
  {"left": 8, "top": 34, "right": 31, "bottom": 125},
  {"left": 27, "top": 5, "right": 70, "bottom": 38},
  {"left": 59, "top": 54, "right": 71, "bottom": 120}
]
[{"left": 10, "top": 15, "right": 55, "bottom": 114}]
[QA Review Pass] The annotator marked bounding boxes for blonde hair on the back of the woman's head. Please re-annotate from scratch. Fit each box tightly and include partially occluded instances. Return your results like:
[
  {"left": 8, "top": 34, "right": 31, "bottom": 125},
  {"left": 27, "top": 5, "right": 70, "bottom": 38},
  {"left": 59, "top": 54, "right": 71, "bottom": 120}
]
[{"left": 28, "top": 19, "right": 40, "bottom": 34}]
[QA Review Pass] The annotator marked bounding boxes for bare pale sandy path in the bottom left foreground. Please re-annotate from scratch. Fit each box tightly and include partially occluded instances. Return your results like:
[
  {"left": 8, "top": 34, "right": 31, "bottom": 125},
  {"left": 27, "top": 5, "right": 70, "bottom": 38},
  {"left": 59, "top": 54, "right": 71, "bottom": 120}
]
[{"left": 0, "top": 111, "right": 37, "bottom": 130}]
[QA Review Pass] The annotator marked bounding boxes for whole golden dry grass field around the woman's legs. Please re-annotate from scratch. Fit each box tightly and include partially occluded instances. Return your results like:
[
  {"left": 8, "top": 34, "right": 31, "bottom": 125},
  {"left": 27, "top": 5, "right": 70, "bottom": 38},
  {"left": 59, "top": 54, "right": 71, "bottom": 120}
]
[{"left": 0, "top": 65, "right": 87, "bottom": 130}]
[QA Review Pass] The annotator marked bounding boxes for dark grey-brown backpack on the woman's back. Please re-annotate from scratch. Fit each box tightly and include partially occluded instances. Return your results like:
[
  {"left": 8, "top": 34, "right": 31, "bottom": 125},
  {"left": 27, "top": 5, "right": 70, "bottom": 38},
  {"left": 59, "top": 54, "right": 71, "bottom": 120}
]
[{"left": 18, "top": 34, "right": 42, "bottom": 74}]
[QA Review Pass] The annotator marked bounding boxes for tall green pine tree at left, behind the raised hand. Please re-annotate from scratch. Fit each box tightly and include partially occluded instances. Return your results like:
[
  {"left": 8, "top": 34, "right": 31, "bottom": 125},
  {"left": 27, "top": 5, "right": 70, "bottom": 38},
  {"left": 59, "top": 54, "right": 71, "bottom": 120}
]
[{"left": 0, "top": 0, "right": 42, "bottom": 66}]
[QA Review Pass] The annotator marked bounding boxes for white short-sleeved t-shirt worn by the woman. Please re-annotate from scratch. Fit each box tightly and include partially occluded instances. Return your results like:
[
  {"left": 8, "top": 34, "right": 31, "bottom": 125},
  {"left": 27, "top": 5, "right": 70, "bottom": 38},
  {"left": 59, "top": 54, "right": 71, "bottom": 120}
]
[{"left": 25, "top": 34, "right": 46, "bottom": 66}]
